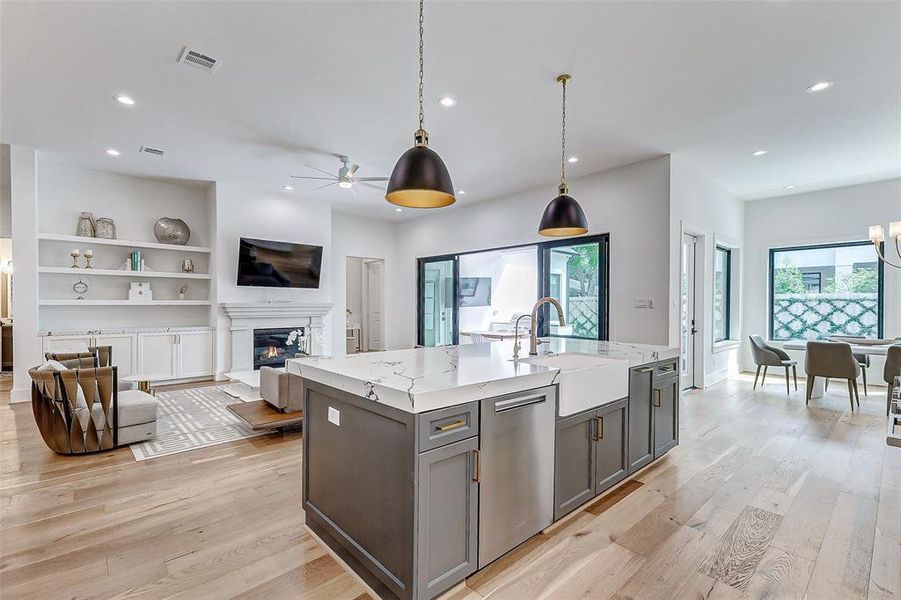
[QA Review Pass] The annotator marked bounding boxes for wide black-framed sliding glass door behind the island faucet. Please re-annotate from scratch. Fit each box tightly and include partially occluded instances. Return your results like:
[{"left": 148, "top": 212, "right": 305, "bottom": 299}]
[{"left": 418, "top": 235, "right": 609, "bottom": 346}]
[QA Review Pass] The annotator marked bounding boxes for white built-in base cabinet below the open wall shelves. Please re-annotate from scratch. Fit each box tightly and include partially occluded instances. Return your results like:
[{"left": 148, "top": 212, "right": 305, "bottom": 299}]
[{"left": 42, "top": 330, "right": 213, "bottom": 380}]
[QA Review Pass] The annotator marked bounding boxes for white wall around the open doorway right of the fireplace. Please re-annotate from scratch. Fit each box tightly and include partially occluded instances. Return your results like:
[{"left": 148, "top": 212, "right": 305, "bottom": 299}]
[{"left": 331, "top": 212, "right": 400, "bottom": 354}]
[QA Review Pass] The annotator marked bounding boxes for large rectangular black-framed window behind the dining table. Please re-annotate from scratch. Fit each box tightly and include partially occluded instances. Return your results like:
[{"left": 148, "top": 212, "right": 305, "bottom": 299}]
[{"left": 769, "top": 242, "right": 883, "bottom": 340}]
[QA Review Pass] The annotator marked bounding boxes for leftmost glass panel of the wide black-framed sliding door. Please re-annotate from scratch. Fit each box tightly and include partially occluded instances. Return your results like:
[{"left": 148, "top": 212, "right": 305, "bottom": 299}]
[{"left": 419, "top": 256, "right": 458, "bottom": 346}]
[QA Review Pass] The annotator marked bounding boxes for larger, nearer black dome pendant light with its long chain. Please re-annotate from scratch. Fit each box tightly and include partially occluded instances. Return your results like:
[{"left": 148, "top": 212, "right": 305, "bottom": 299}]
[{"left": 385, "top": 0, "right": 456, "bottom": 208}]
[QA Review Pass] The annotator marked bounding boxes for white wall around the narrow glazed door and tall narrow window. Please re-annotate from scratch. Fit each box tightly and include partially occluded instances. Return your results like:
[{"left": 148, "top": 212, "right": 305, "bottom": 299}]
[{"left": 669, "top": 154, "right": 744, "bottom": 387}]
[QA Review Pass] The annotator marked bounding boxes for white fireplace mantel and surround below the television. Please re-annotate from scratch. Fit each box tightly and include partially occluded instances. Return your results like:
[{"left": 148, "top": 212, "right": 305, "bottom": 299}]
[{"left": 222, "top": 301, "right": 332, "bottom": 371}]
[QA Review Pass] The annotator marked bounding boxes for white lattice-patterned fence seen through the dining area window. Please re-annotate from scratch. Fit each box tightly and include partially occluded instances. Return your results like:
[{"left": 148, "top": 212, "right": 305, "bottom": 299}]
[{"left": 773, "top": 293, "right": 879, "bottom": 340}]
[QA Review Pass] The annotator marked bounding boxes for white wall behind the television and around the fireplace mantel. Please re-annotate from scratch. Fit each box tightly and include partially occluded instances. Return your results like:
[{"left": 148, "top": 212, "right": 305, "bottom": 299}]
[{"left": 211, "top": 182, "right": 332, "bottom": 375}]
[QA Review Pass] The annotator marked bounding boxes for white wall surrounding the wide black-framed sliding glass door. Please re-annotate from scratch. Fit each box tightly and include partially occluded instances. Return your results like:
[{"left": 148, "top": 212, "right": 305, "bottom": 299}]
[{"left": 392, "top": 156, "right": 670, "bottom": 346}]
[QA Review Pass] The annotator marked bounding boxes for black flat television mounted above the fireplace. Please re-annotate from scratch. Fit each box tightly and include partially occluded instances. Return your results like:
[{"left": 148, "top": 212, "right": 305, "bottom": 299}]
[{"left": 238, "top": 238, "right": 322, "bottom": 288}]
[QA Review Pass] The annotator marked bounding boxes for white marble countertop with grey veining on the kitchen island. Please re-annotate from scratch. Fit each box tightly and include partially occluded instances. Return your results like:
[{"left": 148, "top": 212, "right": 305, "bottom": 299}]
[{"left": 287, "top": 338, "right": 679, "bottom": 413}]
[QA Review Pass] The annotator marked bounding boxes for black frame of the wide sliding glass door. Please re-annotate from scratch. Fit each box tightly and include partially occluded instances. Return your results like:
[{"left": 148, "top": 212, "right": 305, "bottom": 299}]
[{"left": 416, "top": 233, "right": 610, "bottom": 346}]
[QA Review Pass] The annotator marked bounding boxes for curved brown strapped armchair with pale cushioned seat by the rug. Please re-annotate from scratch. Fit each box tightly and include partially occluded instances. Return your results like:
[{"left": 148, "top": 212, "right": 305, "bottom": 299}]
[{"left": 29, "top": 347, "right": 158, "bottom": 454}]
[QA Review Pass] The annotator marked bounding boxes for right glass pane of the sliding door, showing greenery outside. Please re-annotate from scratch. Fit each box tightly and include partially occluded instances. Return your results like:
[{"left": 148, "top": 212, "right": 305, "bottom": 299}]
[{"left": 545, "top": 242, "right": 601, "bottom": 340}]
